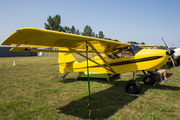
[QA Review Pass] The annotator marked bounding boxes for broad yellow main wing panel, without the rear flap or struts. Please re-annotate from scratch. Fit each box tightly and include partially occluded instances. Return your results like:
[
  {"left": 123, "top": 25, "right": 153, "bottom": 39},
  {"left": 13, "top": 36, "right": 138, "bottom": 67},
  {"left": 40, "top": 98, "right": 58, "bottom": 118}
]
[{"left": 2, "top": 28, "right": 130, "bottom": 52}]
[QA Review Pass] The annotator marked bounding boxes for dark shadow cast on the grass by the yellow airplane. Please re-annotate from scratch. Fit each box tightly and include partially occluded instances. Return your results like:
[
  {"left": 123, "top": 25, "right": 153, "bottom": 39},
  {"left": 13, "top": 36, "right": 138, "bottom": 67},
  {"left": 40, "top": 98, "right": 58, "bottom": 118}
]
[{"left": 57, "top": 74, "right": 180, "bottom": 119}]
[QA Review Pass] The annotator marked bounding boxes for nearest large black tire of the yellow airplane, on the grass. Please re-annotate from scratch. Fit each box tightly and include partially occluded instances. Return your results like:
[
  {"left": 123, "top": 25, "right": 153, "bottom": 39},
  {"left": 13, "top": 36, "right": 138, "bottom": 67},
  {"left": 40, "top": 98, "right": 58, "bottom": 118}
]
[{"left": 125, "top": 80, "right": 141, "bottom": 94}]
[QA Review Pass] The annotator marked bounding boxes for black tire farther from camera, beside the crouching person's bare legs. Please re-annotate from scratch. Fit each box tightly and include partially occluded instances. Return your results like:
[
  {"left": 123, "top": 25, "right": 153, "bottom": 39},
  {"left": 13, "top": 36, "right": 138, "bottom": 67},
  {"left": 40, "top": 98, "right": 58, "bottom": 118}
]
[{"left": 143, "top": 73, "right": 156, "bottom": 85}]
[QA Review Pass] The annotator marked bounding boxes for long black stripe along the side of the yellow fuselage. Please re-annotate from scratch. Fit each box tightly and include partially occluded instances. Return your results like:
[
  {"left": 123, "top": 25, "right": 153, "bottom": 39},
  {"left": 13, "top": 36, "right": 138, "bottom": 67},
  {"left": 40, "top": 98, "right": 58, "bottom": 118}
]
[{"left": 75, "top": 56, "right": 163, "bottom": 69}]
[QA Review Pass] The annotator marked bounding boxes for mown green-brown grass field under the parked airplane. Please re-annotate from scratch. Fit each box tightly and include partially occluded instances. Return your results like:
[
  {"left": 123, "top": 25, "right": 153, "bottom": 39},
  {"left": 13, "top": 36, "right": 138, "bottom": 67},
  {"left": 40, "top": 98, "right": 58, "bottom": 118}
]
[{"left": 0, "top": 55, "right": 180, "bottom": 120}]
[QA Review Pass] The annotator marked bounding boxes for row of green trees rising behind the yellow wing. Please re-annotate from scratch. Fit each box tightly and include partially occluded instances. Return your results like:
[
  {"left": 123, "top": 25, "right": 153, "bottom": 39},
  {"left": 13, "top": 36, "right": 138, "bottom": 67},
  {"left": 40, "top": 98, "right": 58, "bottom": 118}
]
[{"left": 44, "top": 14, "right": 145, "bottom": 44}]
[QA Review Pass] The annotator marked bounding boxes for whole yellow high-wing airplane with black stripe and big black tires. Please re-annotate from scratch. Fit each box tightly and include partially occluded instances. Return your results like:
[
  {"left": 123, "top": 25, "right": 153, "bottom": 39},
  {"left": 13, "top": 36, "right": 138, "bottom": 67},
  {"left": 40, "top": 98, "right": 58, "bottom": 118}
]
[{"left": 2, "top": 28, "right": 173, "bottom": 94}]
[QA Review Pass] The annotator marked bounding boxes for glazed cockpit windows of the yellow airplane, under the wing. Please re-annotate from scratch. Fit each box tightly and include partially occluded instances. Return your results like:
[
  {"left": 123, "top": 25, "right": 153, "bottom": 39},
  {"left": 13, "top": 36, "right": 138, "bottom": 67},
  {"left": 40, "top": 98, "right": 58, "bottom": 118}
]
[{"left": 108, "top": 44, "right": 143, "bottom": 59}]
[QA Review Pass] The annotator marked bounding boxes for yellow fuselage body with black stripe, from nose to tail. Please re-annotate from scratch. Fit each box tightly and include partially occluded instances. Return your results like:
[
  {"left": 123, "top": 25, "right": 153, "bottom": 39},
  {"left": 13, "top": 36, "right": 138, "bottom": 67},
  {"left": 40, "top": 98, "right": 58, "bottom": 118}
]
[{"left": 60, "top": 49, "right": 169, "bottom": 74}]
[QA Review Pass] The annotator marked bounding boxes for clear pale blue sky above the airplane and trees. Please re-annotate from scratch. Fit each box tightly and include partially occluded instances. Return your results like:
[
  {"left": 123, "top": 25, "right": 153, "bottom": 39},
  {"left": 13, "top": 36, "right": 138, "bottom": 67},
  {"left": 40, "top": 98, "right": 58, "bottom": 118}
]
[{"left": 0, "top": 0, "right": 180, "bottom": 47}]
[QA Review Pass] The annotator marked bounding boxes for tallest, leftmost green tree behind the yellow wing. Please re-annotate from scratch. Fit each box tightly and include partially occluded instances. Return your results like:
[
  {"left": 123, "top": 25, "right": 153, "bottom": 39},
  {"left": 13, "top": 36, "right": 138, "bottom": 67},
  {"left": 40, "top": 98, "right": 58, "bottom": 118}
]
[{"left": 44, "top": 15, "right": 62, "bottom": 31}]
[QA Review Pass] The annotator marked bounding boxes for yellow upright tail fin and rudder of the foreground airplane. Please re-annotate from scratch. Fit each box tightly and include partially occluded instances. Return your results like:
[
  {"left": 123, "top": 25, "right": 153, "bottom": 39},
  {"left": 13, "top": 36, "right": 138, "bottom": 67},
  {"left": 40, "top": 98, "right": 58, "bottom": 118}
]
[{"left": 58, "top": 49, "right": 76, "bottom": 73}]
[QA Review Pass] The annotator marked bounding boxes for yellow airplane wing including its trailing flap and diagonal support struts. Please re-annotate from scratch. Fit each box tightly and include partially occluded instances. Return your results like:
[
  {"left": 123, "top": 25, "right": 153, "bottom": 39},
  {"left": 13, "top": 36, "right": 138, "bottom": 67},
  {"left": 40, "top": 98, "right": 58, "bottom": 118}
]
[{"left": 2, "top": 28, "right": 131, "bottom": 73}]
